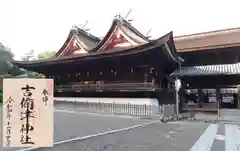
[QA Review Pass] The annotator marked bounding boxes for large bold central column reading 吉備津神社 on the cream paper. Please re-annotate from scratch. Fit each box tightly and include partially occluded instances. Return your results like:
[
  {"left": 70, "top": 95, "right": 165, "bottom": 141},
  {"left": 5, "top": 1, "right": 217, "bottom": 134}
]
[{"left": 20, "top": 85, "right": 35, "bottom": 144}]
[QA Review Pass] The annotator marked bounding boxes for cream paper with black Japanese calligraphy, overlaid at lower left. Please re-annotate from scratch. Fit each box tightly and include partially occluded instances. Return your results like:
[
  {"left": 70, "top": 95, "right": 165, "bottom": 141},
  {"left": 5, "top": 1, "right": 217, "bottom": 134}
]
[{"left": 2, "top": 78, "right": 53, "bottom": 147}]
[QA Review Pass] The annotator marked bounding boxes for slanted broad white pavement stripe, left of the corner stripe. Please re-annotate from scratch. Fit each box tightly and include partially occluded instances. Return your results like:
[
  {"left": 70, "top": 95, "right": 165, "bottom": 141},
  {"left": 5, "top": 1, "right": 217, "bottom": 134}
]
[{"left": 190, "top": 124, "right": 218, "bottom": 151}]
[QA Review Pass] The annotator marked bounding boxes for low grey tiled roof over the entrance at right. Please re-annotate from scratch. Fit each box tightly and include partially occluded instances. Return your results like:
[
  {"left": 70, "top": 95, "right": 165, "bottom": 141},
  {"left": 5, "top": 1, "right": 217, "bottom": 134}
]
[{"left": 171, "top": 63, "right": 240, "bottom": 76}]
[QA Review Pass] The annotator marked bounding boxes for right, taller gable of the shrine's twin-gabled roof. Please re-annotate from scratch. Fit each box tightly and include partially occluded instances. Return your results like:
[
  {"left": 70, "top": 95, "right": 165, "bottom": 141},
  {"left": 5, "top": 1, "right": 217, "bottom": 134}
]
[{"left": 93, "top": 15, "right": 149, "bottom": 51}]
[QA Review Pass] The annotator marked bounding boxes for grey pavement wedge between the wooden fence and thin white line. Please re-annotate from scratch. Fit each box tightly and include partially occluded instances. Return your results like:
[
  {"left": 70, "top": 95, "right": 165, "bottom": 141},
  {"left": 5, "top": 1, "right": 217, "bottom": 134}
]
[{"left": 0, "top": 109, "right": 152, "bottom": 151}]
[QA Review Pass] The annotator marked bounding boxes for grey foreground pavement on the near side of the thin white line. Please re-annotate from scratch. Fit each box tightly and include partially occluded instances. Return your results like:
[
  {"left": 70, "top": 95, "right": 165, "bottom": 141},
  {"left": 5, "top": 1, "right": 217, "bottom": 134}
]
[{"left": 18, "top": 122, "right": 240, "bottom": 151}]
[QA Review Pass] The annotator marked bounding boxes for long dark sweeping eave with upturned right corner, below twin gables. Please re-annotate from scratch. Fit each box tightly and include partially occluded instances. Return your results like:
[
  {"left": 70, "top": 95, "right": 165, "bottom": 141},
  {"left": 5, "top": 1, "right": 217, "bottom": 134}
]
[{"left": 11, "top": 32, "right": 179, "bottom": 68}]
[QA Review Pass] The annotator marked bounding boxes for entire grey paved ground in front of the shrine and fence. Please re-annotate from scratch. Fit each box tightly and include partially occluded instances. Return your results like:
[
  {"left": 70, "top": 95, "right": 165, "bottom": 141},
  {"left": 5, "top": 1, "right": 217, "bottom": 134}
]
[{"left": 0, "top": 107, "right": 240, "bottom": 151}]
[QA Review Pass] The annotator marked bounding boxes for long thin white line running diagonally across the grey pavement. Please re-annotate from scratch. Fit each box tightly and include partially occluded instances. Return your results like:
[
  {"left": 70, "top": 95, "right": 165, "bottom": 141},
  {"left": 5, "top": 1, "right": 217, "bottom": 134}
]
[{"left": 18, "top": 120, "right": 159, "bottom": 151}]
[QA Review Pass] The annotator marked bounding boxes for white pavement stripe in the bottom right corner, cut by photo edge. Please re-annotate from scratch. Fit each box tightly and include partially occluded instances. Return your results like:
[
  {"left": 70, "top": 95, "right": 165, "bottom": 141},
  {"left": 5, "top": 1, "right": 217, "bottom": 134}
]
[{"left": 225, "top": 124, "right": 240, "bottom": 151}]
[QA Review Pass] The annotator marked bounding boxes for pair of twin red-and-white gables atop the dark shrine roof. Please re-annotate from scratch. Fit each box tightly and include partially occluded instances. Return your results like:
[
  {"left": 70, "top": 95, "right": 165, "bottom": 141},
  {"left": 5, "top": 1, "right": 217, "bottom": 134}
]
[{"left": 52, "top": 15, "right": 149, "bottom": 58}]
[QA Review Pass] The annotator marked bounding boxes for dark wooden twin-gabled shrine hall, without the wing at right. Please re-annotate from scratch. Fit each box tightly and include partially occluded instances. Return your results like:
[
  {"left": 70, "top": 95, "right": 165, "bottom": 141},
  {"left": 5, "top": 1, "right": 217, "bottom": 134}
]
[{"left": 12, "top": 16, "right": 181, "bottom": 101}]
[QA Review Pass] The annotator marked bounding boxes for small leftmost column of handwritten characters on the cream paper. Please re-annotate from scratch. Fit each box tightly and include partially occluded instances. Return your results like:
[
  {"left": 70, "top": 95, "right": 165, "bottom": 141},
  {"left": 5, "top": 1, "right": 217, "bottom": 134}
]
[{"left": 4, "top": 96, "right": 14, "bottom": 147}]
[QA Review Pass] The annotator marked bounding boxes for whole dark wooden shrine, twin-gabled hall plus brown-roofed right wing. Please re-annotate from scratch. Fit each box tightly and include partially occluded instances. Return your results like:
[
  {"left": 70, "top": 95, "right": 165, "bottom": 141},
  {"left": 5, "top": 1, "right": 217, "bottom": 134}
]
[{"left": 12, "top": 13, "right": 240, "bottom": 110}]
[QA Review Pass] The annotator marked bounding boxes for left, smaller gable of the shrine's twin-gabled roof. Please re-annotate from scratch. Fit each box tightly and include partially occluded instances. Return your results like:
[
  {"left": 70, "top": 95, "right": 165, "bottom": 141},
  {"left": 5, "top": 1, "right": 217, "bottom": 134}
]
[{"left": 52, "top": 26, "right": 100, "bottom": 58}]
